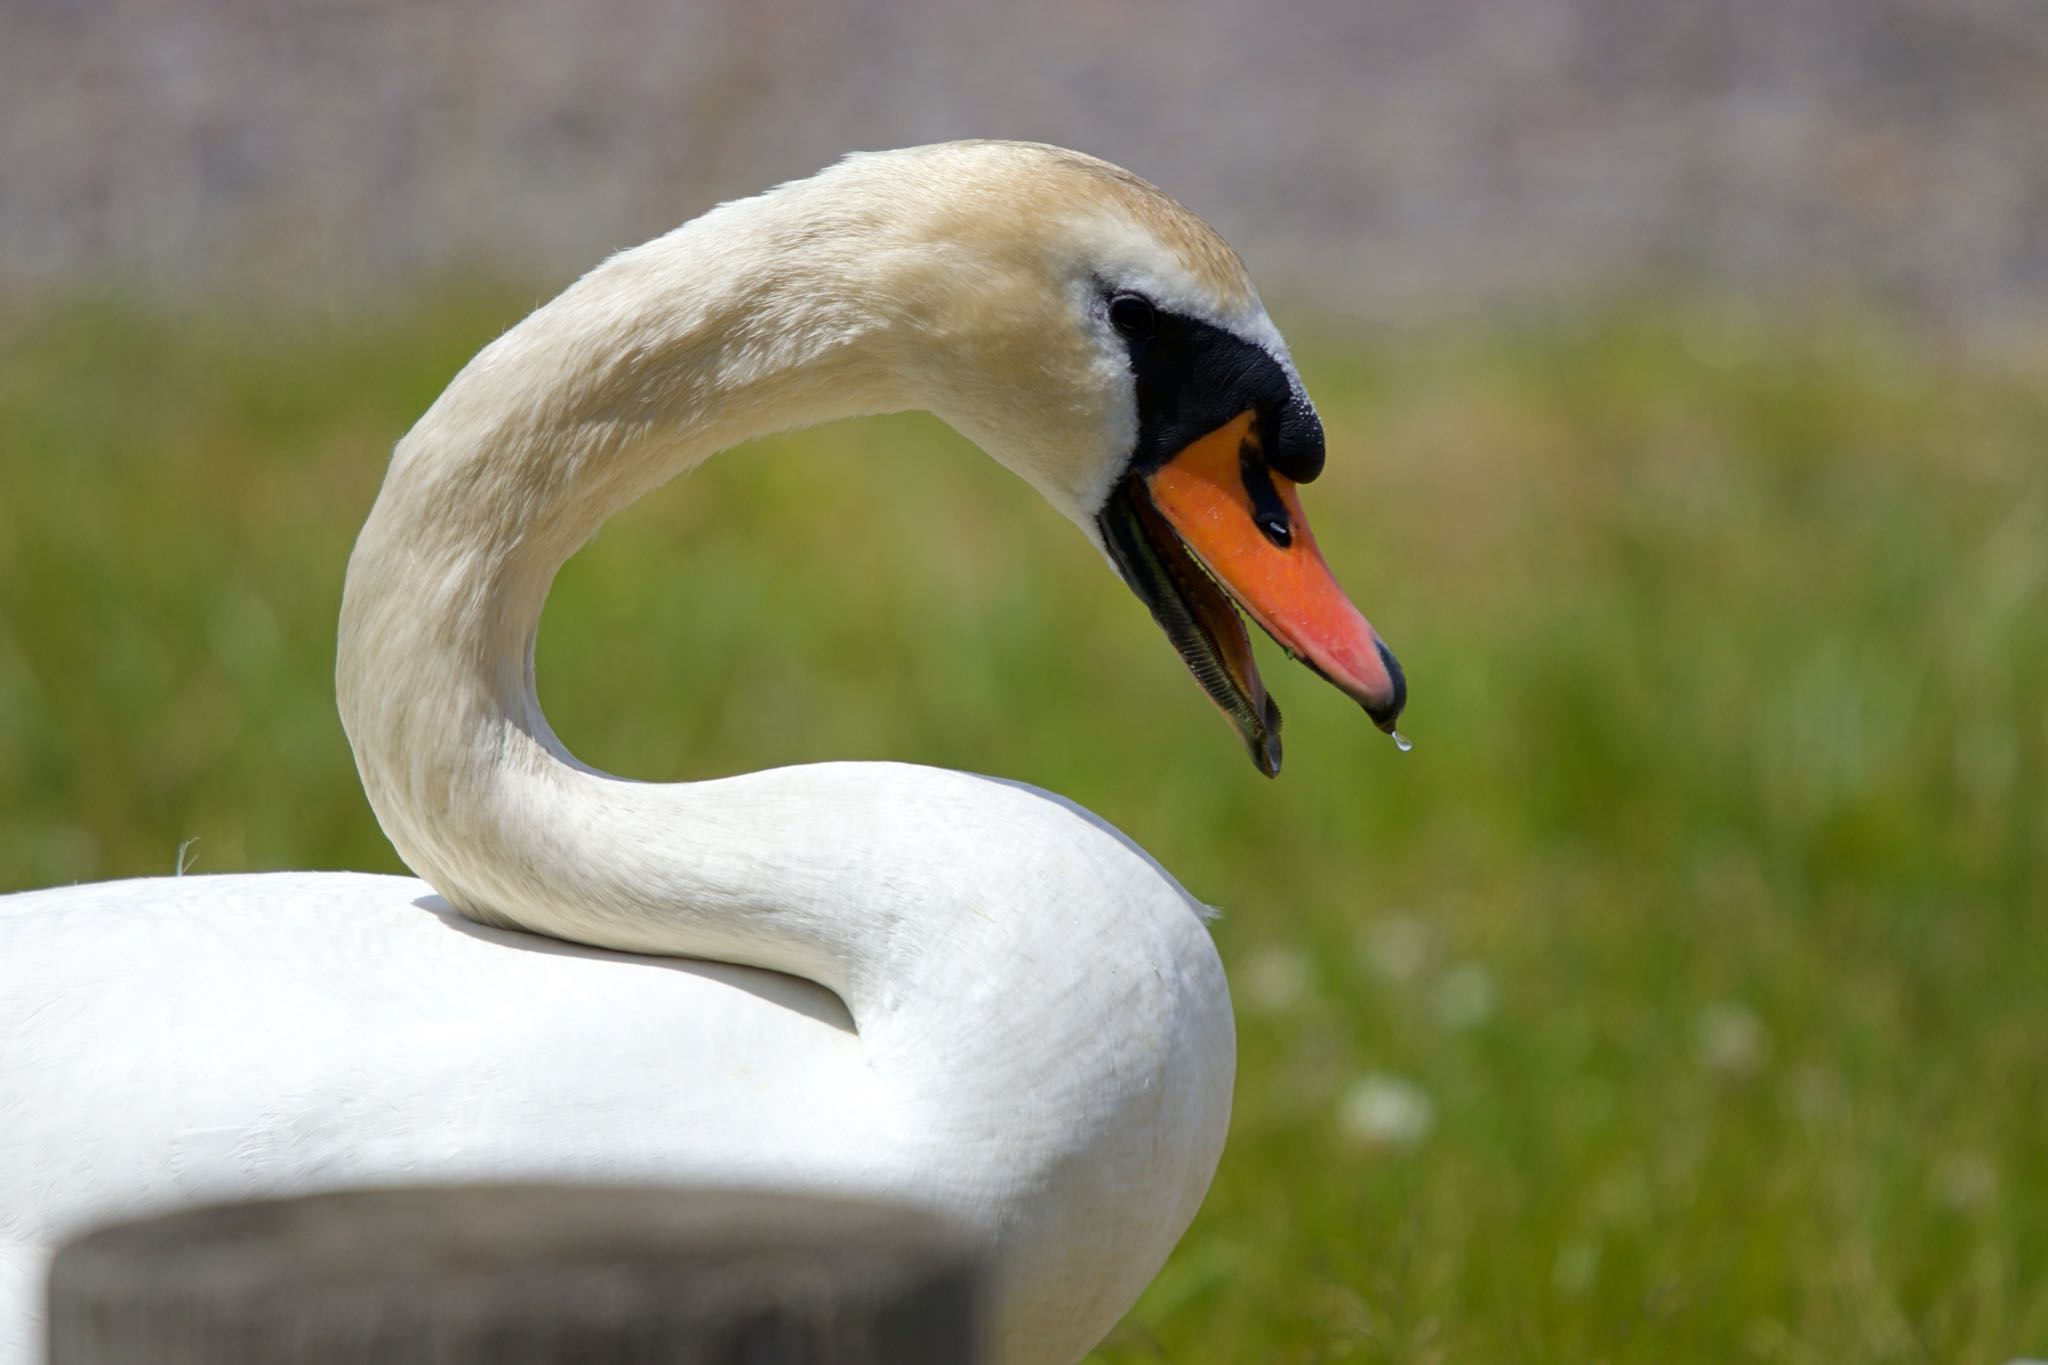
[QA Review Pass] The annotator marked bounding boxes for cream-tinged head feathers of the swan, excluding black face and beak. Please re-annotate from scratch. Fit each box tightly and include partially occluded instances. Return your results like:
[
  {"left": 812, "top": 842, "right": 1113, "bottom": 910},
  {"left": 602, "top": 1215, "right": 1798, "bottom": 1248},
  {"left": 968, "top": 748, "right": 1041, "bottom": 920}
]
[{"left": 737, "top": 141, "right": 1298, "bottom": 538}]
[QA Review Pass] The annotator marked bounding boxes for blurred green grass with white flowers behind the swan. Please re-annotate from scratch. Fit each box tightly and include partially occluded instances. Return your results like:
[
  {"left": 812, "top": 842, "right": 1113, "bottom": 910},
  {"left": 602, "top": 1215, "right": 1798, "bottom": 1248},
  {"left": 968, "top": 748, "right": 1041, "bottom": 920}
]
[{"left": 0, "top": 289, "right": 2048, "bottom": 1365}]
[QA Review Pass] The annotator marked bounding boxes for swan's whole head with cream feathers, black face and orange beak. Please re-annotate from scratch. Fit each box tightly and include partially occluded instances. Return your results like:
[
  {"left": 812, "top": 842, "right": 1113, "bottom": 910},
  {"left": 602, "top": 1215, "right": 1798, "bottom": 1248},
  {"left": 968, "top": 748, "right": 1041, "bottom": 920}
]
[{"left": 813, "top": 143, "right": 1407, "bottom": 776}]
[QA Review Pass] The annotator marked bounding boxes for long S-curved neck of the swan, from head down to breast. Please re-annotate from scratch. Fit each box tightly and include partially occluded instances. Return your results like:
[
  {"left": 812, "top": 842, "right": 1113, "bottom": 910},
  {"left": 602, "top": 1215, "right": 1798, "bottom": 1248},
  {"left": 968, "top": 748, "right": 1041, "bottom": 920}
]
[{"left": 336, "top": 152, "right": 1212, "bottom": 1083}]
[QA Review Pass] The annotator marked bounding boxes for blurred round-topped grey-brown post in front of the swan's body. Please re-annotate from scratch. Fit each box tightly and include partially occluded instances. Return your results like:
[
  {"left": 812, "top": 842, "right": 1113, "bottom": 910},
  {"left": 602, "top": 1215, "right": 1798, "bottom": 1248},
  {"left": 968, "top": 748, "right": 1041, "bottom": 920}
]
[{"left": 49, "top": 1185, "right": 979, "bottom": 1365}]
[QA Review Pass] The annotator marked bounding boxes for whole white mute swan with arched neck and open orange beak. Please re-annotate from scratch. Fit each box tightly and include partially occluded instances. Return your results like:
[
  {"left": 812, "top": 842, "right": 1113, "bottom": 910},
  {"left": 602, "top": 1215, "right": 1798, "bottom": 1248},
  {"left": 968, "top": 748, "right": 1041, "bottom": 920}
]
[{"left": 0, "top": 143, "right": 1405, "bottom": 1365}]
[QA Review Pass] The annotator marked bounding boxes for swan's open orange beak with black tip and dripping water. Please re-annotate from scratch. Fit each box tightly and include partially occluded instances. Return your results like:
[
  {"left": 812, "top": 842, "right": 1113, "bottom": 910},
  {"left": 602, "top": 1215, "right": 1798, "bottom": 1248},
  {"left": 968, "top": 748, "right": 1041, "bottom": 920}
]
[{"left": 1102, "top": 411, "right": 1407, "bottom": 776}]
